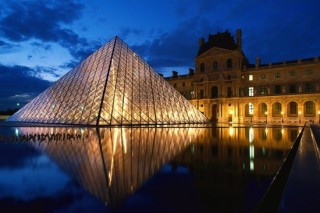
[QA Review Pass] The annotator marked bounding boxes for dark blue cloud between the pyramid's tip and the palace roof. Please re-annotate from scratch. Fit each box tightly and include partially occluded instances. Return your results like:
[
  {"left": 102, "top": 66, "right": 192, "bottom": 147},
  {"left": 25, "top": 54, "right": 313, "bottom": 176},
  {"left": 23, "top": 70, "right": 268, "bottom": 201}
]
[{"left": 132, "top": 16, "right": 218, "bottom": 72}]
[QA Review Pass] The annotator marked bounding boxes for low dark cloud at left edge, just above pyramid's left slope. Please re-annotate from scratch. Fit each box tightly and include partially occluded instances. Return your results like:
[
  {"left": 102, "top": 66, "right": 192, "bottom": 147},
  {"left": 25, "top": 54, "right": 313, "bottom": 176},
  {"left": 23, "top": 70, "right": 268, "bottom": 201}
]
[{"left": 0, "top": 64, "right": 51, "bottom": 110}]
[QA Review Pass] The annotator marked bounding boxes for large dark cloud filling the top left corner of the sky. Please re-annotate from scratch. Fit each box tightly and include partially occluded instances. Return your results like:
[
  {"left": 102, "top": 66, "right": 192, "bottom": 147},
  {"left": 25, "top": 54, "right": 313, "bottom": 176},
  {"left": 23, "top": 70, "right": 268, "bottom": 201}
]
[{"left": 0, "top": 0, "right": 95, "bottom": 60}]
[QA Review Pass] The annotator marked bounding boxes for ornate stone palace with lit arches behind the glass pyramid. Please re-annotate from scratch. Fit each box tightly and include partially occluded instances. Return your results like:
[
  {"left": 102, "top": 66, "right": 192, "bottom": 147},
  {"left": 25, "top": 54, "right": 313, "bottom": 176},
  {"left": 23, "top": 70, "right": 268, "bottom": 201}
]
[{"left": 166, "top": 30, "right": 320, "bottom": 124}]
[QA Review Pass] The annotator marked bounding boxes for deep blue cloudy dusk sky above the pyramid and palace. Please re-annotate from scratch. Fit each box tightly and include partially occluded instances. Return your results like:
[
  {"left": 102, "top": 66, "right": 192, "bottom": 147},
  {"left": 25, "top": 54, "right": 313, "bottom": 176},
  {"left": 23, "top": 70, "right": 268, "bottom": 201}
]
[{"left": 0, "top": 0, "right": 320, "bottom": 110}]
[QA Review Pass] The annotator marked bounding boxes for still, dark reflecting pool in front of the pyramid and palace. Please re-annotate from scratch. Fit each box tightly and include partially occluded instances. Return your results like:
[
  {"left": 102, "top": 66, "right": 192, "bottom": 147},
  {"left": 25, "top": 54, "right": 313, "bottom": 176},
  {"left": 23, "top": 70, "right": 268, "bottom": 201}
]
[{"left": 0, "top": 126, "right": 300, "bottom": 212}]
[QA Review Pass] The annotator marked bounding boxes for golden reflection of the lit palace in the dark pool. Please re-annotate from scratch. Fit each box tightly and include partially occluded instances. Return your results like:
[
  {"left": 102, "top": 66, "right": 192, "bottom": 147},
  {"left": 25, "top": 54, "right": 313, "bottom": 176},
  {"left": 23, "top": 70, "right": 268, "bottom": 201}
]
[{"left": 172, "top": 127, "right": 300, "bottom": 212}]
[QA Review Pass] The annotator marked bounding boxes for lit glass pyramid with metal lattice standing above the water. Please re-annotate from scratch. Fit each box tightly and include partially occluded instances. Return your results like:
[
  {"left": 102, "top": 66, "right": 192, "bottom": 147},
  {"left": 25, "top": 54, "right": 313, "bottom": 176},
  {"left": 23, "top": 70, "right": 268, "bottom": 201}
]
[{"left": 8, "top": 37, "right": 207, "bottom": 126}]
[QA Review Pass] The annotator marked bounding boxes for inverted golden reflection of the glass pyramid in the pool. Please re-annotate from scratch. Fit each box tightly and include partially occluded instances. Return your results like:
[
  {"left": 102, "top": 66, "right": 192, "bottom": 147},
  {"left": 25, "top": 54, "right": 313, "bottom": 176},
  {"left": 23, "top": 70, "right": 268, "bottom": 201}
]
[{"left": 19, "top": 127, "right": 202, "bottom": 206}]
